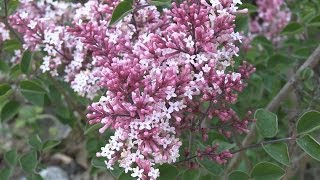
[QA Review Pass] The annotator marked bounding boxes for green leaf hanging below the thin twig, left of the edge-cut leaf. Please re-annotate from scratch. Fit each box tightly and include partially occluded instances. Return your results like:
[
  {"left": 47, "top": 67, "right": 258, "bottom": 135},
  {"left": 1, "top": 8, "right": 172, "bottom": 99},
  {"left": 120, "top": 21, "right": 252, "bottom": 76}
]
[{"left": 262, "top": 143, "right": 290, "bottom": 166}]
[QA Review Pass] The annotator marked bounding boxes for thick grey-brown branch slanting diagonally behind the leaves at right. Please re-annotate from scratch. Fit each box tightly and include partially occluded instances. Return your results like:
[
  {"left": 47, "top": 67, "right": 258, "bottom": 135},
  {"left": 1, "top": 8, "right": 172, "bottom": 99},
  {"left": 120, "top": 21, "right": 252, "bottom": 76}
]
[{"left": 225, "top": 45, "right": 320, "bottom": 174}]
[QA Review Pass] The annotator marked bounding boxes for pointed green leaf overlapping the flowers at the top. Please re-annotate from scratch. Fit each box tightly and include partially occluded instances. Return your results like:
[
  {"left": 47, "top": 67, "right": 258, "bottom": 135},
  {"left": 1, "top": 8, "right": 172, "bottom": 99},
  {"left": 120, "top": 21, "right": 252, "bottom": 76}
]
[{"left": 109, "top": 1, "right": 133, "bottom": 26}]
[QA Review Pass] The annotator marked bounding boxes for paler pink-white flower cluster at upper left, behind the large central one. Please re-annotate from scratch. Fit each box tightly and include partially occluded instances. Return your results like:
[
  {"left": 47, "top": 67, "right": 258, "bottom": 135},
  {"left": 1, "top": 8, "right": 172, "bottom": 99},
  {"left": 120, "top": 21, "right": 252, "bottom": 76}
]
[{"left": 9, "top": 0, "right": 99, "bottom": 98}]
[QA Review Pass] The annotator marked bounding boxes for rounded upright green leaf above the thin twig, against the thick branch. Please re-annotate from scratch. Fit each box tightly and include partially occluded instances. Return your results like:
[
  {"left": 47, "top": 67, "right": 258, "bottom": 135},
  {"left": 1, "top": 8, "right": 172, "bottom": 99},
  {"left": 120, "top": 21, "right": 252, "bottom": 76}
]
[{"left": 254, "top": 109, "right": 278, "bottom": 138}]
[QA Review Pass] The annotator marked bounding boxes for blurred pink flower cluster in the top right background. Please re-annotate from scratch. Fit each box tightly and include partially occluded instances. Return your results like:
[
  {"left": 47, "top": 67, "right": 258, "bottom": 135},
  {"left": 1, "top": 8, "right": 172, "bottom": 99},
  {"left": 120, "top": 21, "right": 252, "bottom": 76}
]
[{"left": 250, "top": 0, "right": 291, "bottom": 43}]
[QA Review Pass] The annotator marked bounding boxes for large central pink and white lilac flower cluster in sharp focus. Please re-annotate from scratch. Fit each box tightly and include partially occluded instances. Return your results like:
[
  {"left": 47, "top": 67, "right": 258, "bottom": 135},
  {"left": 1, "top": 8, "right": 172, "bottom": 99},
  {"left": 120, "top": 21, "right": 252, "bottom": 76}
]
[{"left": 68, "top": 0, "right": 255, "bottom": 179}]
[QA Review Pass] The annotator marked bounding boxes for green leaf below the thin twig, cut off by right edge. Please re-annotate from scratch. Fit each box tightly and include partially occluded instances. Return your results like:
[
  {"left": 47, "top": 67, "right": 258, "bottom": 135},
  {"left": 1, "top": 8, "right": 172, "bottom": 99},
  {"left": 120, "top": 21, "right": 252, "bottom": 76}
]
[{"left": 296, "top": 134, "right": 320, "bottom": 161}]
